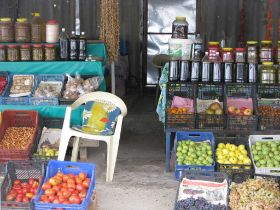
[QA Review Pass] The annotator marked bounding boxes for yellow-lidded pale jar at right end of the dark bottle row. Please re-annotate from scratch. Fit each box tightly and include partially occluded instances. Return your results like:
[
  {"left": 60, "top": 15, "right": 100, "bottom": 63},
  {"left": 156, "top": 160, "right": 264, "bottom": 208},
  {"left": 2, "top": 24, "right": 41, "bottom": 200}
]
[{"left": 260, "top": 62, "right": 276, "bottom": 84}]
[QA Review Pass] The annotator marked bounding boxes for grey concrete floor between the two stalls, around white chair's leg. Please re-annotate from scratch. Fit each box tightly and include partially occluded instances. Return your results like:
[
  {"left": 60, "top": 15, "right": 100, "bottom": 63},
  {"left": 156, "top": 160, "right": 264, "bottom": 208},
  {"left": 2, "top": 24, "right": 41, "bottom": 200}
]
[{"left": 84, "top": 90, "right": 178, "bottom": 210}]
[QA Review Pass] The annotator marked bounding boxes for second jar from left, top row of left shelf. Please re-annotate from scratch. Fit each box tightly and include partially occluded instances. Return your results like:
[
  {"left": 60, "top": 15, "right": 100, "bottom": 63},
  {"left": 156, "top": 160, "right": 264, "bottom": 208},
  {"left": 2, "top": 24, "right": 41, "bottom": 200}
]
[{"left": 15, "top": 18, "right": 31, "bottom": 42}]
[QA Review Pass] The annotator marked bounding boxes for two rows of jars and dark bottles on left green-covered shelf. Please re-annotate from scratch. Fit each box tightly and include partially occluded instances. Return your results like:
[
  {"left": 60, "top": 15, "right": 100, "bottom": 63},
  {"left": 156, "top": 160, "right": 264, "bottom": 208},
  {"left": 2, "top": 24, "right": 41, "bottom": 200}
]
[{"left": 0, "top": 13, "right": 87, "bottom": 62}]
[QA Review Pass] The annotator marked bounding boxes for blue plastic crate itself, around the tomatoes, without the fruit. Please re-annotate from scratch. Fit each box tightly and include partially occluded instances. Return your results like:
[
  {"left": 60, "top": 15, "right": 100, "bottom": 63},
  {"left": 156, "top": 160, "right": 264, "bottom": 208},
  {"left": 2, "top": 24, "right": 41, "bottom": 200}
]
[{"left": 34, "top": 160, "right": 95, "bottom": 210}]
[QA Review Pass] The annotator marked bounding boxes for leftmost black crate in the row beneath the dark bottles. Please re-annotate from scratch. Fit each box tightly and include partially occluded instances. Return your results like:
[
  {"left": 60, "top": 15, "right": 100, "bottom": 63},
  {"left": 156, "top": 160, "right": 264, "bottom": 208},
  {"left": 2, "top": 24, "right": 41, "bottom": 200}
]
[{"left": 165, "top": 82, "right": 195, "bottom": 130}]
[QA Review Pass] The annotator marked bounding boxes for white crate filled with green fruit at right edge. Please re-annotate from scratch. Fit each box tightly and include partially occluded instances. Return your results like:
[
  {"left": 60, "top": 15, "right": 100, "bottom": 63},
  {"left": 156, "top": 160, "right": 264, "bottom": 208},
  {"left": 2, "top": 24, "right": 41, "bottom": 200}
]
[{"left": 249, "top": 135, "right": 280, "bottom": 176}]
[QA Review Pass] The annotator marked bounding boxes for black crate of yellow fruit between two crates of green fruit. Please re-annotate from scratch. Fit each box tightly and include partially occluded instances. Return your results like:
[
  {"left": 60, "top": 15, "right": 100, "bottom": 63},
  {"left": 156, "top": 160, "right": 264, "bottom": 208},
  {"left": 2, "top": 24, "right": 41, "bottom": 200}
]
[{"left": 215, "top": 137, "right": 254, "bottom": 182}]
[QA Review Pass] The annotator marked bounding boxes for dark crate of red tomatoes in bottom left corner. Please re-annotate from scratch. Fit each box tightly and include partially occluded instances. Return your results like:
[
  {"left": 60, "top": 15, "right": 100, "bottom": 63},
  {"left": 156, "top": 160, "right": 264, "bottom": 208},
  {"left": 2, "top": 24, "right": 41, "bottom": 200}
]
[{"left": 1, "top": 161, "right": 45, "bottom": 210}]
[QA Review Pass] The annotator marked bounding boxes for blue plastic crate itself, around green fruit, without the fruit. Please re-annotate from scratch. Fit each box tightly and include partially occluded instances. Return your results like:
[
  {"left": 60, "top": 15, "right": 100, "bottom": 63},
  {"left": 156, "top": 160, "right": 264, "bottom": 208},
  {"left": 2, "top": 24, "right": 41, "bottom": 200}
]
[{"left": 174, "top": 132, "right": 215, "bottom": 180}]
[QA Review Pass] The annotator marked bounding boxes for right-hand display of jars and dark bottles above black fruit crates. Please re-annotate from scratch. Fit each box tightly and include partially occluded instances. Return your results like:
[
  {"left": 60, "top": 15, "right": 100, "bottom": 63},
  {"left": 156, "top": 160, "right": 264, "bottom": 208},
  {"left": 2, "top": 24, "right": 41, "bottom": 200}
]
[{"left": 166, "top": 40, "right": 280, "bottom": 132}]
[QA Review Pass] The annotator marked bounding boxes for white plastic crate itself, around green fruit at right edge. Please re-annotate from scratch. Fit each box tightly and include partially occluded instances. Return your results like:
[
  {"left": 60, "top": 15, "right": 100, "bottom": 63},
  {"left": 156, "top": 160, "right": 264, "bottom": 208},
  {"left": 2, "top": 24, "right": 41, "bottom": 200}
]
[{"left": 249, "top": 135, "right": 280, "bottom": 176}]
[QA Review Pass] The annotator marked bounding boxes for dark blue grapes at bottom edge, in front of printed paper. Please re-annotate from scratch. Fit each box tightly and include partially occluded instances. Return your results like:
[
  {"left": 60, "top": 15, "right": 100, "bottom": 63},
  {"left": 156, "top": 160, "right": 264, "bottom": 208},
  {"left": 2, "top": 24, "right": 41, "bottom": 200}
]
[{"left": 175, "top": 197, "right": 226, "bottom": 210}]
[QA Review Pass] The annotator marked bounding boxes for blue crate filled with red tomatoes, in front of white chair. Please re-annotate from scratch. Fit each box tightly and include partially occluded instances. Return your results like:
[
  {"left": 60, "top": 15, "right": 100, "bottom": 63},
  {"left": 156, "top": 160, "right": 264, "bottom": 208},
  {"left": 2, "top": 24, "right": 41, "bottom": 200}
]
[{"left": 34, "top": 160, "right": 95, "bottom": 210}]
